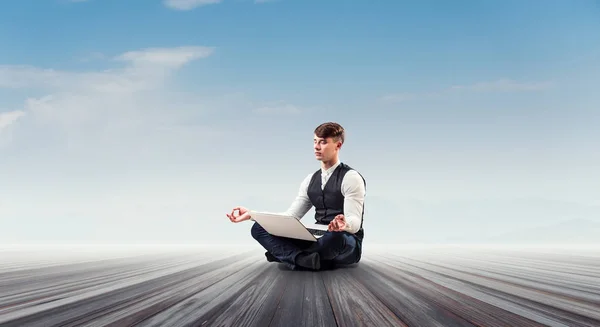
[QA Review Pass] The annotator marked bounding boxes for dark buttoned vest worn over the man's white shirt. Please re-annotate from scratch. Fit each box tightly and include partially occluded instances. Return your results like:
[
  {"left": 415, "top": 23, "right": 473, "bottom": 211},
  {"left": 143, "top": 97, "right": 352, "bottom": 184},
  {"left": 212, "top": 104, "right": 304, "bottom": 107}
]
[{"left": 308, "top": 163, "right": 367, "bottom": 241}]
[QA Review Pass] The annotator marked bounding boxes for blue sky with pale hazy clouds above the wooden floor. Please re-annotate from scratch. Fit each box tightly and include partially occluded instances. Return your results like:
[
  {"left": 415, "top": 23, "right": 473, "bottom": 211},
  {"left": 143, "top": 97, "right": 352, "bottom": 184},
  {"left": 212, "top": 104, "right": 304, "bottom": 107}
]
[{"left": 0, "top": 0, "right": 600, "bottom": 243}]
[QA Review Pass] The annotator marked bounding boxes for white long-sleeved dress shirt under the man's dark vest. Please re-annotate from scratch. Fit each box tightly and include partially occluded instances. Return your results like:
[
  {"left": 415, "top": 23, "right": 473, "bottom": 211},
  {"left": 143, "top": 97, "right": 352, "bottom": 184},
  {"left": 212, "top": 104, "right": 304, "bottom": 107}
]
[{"left": 283, "top": 160, "right": 366, "bottom": 234}]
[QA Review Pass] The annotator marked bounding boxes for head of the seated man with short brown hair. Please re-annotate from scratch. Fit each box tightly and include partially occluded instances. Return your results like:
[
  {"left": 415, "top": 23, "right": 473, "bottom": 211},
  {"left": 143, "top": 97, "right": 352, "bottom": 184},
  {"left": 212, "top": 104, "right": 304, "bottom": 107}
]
[{"left": 314, "top": 122, "right": 346, "bottom": 162}]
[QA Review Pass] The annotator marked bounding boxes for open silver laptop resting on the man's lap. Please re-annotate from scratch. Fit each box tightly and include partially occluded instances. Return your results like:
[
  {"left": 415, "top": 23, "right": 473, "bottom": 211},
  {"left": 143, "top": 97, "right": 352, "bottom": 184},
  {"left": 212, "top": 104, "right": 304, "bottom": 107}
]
[{"left": 250, "top": 211, "right": 328, "bottom": 242}]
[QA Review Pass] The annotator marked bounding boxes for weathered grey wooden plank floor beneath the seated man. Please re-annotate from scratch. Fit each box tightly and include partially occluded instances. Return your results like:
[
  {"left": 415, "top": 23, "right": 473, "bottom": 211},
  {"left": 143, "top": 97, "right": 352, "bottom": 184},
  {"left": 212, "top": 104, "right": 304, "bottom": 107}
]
[{"left": 0, "top": 246, "right": 600, "bottom": 327}]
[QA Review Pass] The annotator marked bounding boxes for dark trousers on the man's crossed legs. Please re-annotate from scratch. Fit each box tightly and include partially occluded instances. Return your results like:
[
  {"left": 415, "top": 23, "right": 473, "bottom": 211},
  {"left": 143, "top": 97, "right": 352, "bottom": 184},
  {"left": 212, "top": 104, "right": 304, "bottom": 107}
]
[{"left": 251, "top": 222, "right": 361, "bottom": 269}]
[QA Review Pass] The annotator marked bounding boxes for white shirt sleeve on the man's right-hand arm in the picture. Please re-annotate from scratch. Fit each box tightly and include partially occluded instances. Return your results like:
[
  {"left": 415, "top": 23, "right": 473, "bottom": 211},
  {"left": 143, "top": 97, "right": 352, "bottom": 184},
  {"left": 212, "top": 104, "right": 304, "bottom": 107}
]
[{"left": 342, "top": 170, "right": 366, "bottom": 234}]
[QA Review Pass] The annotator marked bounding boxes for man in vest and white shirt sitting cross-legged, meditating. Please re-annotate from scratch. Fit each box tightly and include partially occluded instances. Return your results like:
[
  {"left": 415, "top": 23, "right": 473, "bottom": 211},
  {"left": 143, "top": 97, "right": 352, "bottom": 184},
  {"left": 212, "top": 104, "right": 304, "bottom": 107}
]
[{"left": 227, "top": 122, "right": 366, "bottom": 270}]
